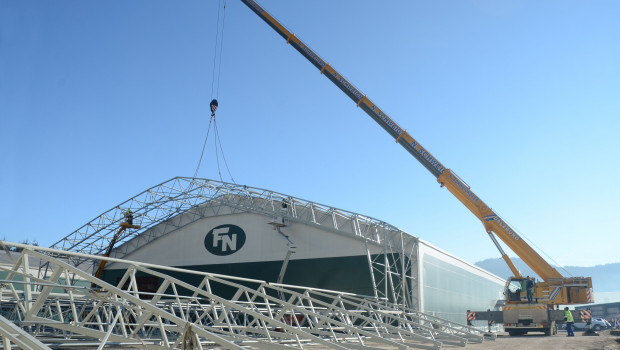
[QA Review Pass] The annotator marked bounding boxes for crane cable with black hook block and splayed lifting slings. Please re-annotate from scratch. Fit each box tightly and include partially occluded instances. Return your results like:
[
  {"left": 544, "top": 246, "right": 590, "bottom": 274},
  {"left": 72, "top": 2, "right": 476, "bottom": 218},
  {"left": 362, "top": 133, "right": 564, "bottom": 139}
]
[{"left": 194, "top": 0, "right": 235, "bottom": 182}]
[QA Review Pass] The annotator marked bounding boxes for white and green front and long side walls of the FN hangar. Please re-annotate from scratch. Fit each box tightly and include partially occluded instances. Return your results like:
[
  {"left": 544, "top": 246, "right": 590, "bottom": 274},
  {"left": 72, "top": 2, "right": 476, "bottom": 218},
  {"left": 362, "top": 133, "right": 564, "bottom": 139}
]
[{"left": 104, "top": 212, "right": 505, "bottom": 323}]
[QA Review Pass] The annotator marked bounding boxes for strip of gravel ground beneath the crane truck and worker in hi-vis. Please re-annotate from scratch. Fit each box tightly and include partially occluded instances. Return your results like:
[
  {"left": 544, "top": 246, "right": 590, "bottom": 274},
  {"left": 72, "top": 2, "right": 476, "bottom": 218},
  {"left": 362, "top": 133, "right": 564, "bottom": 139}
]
[{"left": 448, "top": 330, "right": 620, "bottom": 350}]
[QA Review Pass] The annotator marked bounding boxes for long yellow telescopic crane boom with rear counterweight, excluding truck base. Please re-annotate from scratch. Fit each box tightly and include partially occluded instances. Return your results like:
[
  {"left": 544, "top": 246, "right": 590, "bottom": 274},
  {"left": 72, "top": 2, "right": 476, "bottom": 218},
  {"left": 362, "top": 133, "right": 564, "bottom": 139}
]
[{"left": 241, "top": 0, "right": 592, "bottom": 304}]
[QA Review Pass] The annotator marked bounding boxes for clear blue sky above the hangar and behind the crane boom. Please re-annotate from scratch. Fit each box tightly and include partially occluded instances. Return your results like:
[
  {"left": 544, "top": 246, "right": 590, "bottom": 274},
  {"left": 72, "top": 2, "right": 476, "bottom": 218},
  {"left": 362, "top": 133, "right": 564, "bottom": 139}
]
[{"left": 0, "top": 0, "right": 620, "bottom": 266}]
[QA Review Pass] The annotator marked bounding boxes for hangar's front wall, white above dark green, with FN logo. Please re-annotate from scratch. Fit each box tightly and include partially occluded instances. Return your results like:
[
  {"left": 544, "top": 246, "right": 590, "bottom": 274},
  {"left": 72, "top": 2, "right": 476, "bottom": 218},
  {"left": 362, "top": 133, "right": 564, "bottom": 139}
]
[{"left": 103, "top": 213, "right": 381, "bottom": 295}]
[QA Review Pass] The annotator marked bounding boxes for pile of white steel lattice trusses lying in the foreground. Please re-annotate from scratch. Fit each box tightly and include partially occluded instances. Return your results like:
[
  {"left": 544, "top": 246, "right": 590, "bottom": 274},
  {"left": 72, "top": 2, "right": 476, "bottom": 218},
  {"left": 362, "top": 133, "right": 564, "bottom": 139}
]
[{"left": 0, "top": 242, "right": 494, "bottom": 349}]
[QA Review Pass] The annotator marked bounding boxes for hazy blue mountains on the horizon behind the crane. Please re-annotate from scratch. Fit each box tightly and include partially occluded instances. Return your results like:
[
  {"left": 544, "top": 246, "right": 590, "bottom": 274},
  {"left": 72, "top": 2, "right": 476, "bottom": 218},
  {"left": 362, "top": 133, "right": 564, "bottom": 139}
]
[{"left": 475, "top": 258, "right": 620, "bottom": 292}]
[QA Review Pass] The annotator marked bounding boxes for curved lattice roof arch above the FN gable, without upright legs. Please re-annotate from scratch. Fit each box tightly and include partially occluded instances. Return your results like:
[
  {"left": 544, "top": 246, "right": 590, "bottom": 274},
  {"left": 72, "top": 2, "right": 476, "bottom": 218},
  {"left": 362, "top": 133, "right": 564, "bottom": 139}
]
[{"left": 51, "top": 177, "right": 415, "bottom": 262}]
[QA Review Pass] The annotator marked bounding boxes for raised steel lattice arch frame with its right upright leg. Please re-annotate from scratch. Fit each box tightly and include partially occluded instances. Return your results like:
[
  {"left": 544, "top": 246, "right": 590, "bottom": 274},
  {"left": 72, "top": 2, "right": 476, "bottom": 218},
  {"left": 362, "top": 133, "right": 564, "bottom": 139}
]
[{"left": 51, "top": 177, "right": 419, "bottom": 310}]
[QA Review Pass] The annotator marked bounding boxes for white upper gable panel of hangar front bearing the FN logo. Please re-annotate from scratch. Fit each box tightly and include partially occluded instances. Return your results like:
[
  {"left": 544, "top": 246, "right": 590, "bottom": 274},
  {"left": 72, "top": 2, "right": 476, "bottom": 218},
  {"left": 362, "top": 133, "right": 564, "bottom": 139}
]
[{"left": 110, "top": 213, "right": 380, "bottom": 267}]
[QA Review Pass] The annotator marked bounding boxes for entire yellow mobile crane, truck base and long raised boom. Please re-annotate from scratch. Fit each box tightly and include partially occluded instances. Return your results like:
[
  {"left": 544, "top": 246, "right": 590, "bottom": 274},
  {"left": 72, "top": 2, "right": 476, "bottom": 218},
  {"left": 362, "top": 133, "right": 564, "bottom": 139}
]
[{"left": 241, "top": 0, "right": 593, "bottom": 335}]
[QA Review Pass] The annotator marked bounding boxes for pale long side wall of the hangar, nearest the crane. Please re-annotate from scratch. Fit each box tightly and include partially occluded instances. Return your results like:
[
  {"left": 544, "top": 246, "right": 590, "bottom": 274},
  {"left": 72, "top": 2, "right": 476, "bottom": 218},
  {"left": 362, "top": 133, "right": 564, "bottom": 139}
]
[{"left": 419, "top": 241, "right": 506, "bottom": 323}]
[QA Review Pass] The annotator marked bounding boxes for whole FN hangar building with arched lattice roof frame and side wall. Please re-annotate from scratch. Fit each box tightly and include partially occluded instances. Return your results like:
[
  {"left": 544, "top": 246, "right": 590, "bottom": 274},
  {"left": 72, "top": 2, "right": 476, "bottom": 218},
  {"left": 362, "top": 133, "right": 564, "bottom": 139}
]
[{"left": 52, "top": 177, "right": 505, "bottom": 323}]
